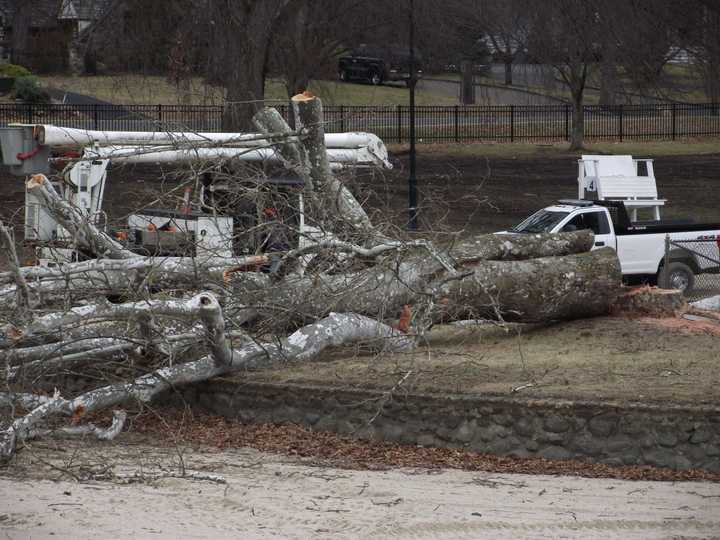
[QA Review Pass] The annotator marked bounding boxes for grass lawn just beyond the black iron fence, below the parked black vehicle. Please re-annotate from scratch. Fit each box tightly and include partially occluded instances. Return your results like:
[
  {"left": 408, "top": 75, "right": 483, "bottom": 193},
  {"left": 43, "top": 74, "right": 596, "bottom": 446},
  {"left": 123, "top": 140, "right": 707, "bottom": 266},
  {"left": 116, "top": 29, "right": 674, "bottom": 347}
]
[{"left": 41, "top": 75, "right": 457, "bottom": 105}]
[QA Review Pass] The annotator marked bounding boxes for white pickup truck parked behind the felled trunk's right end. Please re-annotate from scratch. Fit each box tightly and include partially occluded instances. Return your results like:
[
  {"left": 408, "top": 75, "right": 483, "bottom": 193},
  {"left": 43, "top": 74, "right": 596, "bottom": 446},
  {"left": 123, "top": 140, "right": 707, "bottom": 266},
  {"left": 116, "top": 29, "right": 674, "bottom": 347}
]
[{"left": 503, "top": 200, "right": 720, "bottom": 294}]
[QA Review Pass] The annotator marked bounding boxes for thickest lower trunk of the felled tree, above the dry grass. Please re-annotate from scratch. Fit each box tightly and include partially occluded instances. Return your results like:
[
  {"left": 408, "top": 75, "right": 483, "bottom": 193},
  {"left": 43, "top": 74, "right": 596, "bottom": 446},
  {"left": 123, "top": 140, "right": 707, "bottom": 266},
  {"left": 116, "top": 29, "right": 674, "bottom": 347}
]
[{"left": 231, "top": 245, "right": 621, "bottom": 322}]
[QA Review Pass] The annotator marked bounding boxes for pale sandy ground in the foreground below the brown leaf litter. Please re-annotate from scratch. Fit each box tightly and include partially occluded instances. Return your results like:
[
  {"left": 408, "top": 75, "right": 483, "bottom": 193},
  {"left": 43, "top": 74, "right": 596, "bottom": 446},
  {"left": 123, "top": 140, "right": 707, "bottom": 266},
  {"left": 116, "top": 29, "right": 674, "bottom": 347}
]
[{"left": 0, "top": 442, "right": 720, "bottom": 539}]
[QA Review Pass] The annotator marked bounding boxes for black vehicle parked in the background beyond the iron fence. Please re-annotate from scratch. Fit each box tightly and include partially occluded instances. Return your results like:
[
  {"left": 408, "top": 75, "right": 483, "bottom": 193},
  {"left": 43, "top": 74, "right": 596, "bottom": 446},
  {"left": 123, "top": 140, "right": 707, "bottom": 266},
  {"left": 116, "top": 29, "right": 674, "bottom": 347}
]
[{"left": 338, "top": 45, "right": 422, "bottom": 85}]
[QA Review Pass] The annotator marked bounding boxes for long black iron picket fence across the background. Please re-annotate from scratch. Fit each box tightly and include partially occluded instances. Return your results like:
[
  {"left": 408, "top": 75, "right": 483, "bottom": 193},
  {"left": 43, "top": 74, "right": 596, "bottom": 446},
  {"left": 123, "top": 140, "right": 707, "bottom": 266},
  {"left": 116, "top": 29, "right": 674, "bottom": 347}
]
[{"left": 0, "top": 103, "right": 720, "bottom": 143}]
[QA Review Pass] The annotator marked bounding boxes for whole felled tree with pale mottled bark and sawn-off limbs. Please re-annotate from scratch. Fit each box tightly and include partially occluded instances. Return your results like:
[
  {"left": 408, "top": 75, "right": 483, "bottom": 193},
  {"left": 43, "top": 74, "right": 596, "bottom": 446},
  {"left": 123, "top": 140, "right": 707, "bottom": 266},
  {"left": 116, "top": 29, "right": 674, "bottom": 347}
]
[{"left": 0, "top": 93, "right": 621, "bottom": 457}]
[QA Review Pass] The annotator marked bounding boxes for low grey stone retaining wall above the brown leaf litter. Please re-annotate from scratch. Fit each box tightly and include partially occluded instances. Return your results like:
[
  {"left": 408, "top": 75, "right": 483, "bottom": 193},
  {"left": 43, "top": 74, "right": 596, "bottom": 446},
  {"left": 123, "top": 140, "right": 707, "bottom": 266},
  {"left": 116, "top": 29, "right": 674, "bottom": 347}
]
[{"left": 185, "top": 380, "right": 720, "bottom": 471}]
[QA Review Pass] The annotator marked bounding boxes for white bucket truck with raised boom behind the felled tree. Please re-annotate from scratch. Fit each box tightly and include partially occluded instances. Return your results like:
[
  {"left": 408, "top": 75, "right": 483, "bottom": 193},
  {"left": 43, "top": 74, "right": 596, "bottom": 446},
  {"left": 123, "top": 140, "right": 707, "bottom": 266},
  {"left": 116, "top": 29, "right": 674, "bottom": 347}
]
[{"left": 0, "top": 125, "right": 391, "bottom": 265}]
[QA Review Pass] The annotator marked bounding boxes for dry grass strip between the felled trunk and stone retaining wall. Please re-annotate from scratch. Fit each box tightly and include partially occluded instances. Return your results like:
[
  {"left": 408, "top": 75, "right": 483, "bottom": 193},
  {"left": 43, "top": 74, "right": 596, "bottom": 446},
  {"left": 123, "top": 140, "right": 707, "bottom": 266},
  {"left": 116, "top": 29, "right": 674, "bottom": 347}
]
[{"left": 241, "top": 317, "right": 720, "bottom": 405}]
